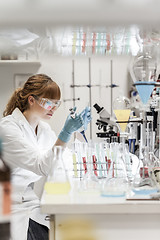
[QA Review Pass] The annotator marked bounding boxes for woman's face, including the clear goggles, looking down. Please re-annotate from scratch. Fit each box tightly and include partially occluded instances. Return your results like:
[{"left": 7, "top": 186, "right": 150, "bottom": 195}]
[{"left": 29, "top": 96, "right": 61, "bottom": 120}]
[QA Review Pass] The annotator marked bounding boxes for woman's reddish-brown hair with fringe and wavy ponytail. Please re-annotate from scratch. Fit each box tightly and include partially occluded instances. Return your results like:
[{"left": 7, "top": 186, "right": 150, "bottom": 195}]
[{"left": 3, "top": 74, "right": 61, "bottom": 117}]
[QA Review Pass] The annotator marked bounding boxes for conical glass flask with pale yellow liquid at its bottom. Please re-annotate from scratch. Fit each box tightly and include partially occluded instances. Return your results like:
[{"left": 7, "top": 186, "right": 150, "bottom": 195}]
[{"left": 44, "top": 146, "right": 71, "bottom": 194}]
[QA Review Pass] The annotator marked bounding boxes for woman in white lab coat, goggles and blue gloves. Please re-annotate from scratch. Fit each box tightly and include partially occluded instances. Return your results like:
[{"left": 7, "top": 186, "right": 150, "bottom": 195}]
[{"left": 0, "top": 74, "right": 91, "bottom": 240}]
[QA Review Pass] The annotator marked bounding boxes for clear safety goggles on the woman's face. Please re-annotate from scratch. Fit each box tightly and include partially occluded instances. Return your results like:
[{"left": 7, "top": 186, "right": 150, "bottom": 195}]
[{"left": 38, "top": 98, "right": 61, "bottom": 110}]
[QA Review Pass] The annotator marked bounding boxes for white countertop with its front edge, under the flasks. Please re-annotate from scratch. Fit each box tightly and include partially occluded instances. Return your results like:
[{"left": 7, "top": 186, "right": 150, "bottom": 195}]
[{"left": 41, "top": 191, "right": 160, "bottom": 215}]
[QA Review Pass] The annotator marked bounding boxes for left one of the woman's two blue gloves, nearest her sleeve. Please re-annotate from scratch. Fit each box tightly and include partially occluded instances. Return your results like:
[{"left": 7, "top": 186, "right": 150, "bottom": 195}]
[{"left": 58, "top": 107, "right": 84, "bottom": 142}]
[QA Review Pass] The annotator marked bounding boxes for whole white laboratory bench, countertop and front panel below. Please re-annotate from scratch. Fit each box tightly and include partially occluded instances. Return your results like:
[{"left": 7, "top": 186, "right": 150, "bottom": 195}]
[{"left": 41, "top": 188, "right": 160, "bottom": 240}]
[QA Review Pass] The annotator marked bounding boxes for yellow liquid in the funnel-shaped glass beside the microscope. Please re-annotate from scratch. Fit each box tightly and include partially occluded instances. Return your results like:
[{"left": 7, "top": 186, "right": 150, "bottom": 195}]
[{"left": 114, "top": 109, "right": 131, "bottom": 132}]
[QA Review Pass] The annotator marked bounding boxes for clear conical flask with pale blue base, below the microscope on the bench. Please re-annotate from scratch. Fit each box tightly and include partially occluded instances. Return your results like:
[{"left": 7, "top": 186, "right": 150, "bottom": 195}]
[{"left": 101, "top": 143, "right": 128, "bottom": 197}]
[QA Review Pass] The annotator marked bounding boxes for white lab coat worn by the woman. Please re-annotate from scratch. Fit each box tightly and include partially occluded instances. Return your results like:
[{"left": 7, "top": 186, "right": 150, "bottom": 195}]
[{"left": 0, "top": 108, "right": 57, "bottom": 240}]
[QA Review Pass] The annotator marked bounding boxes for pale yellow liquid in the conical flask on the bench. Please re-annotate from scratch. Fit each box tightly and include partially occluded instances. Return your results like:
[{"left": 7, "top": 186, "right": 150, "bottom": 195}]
[{"left": 44, "top": 182, "right": 71, "bottom": 195}]
